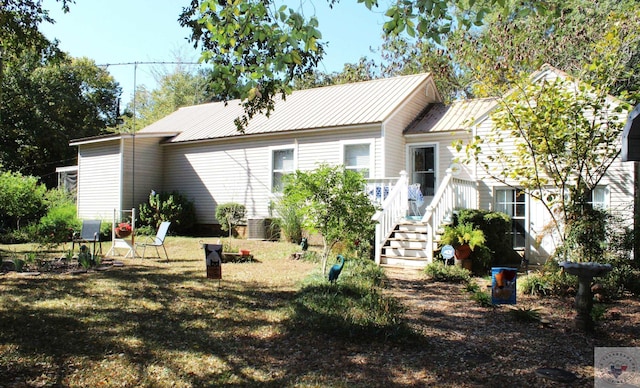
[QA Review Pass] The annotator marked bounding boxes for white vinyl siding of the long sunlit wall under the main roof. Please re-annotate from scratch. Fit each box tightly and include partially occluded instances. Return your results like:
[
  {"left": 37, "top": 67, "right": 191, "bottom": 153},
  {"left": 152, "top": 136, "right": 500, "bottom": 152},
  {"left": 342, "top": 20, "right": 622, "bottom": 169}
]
[{"left": 164, "top": 127, "right": 379, "bottom": 224}]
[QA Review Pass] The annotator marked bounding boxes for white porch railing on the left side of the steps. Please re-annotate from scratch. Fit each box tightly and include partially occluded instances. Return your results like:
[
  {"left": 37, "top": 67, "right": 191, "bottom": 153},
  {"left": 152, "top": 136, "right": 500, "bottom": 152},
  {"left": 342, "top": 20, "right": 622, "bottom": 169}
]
[{"left": 367, "top": 171, "right": 409, "bottom": 264}]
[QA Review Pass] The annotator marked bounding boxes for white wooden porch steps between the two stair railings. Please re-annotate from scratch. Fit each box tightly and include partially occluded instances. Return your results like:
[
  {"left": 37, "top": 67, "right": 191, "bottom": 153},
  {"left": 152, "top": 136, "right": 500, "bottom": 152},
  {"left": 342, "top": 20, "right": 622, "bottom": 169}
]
[{"left": 380, "top": 219, "right": 433, "bottom": 268}]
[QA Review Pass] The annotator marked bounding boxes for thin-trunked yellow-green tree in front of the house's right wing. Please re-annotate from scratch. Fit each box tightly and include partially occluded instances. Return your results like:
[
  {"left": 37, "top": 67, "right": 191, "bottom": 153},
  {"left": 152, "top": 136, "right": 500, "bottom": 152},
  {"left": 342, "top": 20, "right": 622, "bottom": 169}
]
[{"left": 456, "top": 10, "right": 640, "bottom": 260}]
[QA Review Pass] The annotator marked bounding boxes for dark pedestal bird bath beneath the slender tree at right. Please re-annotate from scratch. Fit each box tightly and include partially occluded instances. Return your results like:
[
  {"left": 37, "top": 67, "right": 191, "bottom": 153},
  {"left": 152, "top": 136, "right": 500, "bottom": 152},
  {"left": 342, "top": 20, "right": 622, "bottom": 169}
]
[{"left": 560, "top": 261, "right": 612, "bottom": 331}]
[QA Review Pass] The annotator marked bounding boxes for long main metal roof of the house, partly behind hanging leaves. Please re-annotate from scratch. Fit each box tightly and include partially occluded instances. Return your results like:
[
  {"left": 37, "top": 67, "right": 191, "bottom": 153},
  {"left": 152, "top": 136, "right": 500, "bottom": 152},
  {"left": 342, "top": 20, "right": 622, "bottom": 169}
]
[{"left": 138, "top": 74, "right": 438, "bottom": 143}]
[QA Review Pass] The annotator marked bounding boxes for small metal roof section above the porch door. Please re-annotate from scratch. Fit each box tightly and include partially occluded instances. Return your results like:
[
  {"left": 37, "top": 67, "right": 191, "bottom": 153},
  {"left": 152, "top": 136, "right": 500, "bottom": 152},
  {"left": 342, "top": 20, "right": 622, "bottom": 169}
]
[{"left": 404, "top": 98, "right": 497, "bottom": 135}]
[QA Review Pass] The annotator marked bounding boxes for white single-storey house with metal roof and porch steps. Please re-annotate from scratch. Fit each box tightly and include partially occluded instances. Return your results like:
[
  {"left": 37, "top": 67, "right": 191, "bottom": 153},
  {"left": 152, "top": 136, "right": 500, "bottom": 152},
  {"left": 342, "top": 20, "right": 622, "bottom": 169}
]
[{"left": 71, "top": 68, "right": 633, "bottom": 266}]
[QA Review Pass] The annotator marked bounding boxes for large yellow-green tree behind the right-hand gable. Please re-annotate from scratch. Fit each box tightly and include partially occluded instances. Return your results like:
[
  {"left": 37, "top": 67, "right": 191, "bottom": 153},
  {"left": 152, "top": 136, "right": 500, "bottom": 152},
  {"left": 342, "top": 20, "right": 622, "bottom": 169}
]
[{"left": 445, "top": 0, "right": 640, "bottom": 97}]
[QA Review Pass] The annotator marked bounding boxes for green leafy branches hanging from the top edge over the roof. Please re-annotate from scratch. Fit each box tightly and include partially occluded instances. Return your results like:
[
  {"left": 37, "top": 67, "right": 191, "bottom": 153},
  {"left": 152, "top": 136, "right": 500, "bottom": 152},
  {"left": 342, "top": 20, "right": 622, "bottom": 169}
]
[{"left": 179, "top": 0, "right": 547, "bottom": 130}]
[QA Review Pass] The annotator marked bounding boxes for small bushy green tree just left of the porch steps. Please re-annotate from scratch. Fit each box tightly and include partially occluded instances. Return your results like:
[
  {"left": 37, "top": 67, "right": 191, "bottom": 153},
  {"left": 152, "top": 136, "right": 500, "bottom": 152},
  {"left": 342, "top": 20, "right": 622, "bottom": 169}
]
[{"left": 283, "top": 164, "right": 375, "bottom": 273}]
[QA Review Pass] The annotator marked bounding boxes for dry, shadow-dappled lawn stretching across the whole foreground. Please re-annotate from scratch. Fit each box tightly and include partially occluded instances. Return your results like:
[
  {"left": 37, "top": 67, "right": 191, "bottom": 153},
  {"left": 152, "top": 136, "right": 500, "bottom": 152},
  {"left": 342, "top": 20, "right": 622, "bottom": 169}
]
[{"left": 0, "top": 237, "right": 640, "bottom": 388}]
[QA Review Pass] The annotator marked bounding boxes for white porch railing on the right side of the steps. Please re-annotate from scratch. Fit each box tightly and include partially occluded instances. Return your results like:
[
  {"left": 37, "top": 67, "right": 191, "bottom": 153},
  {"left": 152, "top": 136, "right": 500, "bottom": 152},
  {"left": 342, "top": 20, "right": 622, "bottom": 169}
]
[{"left": 422, "top": 171, "right": 478, "bottom": 258}]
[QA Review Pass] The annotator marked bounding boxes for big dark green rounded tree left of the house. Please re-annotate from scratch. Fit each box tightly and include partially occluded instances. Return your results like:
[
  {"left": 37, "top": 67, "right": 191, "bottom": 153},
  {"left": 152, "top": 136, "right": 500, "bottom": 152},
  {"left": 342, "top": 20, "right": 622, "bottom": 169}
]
[{"left": 0, "top": 49, "right": 120, "bottom": 187}]
